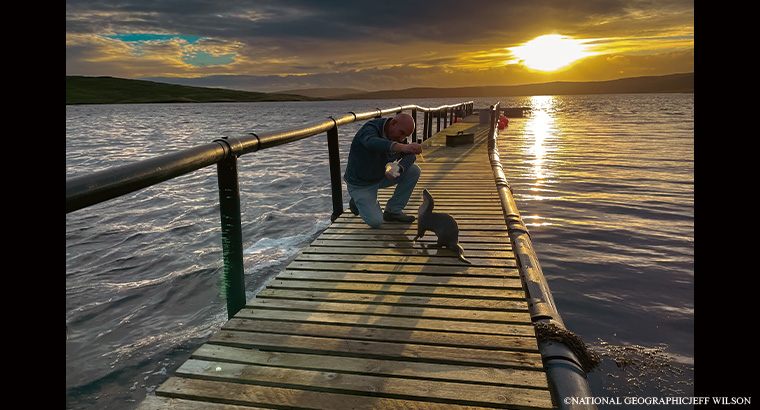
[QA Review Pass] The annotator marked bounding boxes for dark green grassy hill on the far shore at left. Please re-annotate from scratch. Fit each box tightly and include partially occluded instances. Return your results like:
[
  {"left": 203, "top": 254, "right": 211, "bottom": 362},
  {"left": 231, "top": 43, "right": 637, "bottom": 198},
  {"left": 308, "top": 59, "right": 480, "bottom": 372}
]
[{"left": 66, "top": 76, "right": 320, "bottom": 105}]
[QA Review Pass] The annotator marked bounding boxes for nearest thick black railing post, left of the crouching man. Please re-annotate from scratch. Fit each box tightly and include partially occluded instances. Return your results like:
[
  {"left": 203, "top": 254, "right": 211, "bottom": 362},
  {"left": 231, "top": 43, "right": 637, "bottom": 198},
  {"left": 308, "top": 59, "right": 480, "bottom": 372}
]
[{"left": 217, "top": 154, "right": 245, "bottom": 319}]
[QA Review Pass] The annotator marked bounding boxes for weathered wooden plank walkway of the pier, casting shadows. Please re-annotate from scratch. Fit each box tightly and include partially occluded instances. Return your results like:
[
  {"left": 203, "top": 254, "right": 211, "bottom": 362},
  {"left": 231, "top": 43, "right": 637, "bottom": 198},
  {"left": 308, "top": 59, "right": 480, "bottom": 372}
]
[{"left": 139, "top": 115, "right": 552, "bottom": 410}]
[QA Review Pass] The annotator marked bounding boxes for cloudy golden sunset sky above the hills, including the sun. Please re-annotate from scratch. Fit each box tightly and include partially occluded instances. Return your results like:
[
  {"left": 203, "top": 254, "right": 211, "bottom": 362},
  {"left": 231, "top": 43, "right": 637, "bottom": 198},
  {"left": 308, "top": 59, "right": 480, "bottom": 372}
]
[{"left": 66, "top": 0, "right": 694, "bottom": 92}]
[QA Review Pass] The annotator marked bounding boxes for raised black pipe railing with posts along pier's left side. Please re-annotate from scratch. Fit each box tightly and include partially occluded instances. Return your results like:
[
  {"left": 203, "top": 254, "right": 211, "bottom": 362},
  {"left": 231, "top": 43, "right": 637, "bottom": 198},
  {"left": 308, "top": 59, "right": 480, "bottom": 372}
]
[{"left": 66, "top": 101, "right": 473, "bottom": 318}]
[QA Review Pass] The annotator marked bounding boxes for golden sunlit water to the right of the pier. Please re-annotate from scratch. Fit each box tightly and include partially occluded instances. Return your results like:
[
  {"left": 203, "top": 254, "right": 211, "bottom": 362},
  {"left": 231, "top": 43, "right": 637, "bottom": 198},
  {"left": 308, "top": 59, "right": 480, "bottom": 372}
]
[{"left": 499, "top": 94, "right": 694, "bottom": 408}]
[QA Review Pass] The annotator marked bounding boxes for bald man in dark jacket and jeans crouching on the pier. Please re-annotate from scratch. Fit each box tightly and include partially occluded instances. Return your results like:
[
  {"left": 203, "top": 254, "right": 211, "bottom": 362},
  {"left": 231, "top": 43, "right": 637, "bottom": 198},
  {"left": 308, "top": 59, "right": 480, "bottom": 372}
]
[{"left": 343, "top": 113, "right": 422, "bottom": 228}]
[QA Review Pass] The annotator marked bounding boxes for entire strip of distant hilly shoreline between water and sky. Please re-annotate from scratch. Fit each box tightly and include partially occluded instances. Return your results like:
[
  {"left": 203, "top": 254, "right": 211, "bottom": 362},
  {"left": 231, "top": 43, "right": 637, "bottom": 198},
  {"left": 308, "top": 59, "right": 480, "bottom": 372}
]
[{"left": 66, "top": 73, "right": 694, "bottom": 105}]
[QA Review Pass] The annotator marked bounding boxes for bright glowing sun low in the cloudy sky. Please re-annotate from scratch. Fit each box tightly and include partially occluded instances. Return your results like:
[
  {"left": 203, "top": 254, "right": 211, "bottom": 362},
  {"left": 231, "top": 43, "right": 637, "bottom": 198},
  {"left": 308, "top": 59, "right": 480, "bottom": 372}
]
[{"left": 508, "top": 34, "right": 596, "bottom": 71}]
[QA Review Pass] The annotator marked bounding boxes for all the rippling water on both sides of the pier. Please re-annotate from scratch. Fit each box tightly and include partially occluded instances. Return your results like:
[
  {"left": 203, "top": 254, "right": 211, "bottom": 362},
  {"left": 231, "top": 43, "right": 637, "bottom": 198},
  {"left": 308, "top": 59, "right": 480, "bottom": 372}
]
[{"left": 66, "top": 94, "right": 694, "bottom": 410}]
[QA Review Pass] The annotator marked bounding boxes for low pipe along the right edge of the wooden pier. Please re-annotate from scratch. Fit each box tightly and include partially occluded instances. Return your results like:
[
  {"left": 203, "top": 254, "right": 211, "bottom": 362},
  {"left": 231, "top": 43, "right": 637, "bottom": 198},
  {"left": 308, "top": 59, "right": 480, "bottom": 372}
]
[{"left": 488, "top": 102, "right": 596, "bottom": 409}]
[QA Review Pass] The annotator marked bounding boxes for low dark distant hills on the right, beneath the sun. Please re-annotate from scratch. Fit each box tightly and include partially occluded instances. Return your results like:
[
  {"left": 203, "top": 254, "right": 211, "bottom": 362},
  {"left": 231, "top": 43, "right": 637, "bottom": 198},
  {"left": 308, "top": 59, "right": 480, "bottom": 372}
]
[{"left": 331, "top": 73, "right": 694, "bottom": 100}]
